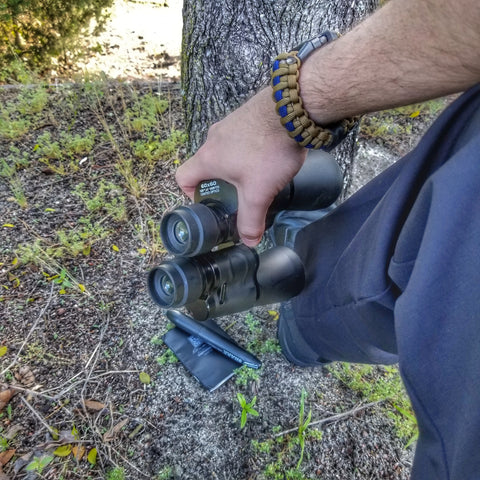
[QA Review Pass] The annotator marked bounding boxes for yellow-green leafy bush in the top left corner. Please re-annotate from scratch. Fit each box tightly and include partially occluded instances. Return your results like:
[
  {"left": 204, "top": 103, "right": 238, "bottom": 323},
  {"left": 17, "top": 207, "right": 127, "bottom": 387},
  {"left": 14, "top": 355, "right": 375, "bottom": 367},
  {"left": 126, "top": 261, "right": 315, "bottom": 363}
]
[{"left": 0, "top": 0, "right": 113, "bottom": 80}]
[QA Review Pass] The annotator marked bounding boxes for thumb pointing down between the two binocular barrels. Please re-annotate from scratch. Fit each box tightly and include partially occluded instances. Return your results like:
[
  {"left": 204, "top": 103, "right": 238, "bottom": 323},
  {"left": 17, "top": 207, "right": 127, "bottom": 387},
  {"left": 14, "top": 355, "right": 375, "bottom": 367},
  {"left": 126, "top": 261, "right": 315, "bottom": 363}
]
[{"left": 237, "top": 188, "right": 272, "bottom": 247}]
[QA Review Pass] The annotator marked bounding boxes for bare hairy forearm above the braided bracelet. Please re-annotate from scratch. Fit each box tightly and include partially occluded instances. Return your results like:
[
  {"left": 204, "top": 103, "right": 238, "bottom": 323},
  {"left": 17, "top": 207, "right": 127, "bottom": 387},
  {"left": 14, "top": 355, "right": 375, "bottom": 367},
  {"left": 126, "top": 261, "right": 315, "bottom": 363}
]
[{"left": 299, "top": 0, "right": 480, "bottom": 124}]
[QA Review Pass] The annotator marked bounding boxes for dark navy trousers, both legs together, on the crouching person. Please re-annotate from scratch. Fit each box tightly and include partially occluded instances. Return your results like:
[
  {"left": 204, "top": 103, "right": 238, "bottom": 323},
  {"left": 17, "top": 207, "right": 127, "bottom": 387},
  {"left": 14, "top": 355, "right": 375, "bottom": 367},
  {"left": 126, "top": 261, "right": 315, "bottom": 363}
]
[{"left": 292, "top": 85, "right": 480, "bottom": 480}]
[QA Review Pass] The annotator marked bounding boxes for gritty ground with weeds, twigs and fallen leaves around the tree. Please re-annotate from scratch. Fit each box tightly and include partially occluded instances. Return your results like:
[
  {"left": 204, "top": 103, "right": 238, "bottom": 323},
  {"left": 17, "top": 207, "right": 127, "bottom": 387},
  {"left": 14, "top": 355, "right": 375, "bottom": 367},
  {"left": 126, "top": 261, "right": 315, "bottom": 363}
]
[{"left": 0, "top": 1, "right": 452, "bottom": 480}]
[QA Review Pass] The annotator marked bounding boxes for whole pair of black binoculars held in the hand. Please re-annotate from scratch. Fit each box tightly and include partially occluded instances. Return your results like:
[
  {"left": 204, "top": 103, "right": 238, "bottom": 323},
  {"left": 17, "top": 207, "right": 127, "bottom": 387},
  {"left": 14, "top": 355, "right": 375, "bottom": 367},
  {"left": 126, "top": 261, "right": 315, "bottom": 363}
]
[{"left": 148, "top": 150, "right": 343, "bottom": 320}]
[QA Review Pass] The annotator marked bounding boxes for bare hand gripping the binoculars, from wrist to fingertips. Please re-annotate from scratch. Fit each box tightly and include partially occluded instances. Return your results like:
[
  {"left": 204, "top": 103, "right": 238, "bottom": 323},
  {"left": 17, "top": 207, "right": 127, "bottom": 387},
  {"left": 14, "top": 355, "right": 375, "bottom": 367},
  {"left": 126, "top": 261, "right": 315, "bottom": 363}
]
[{"left": 176, "top": 88, "right": 306, "bottom": 246}]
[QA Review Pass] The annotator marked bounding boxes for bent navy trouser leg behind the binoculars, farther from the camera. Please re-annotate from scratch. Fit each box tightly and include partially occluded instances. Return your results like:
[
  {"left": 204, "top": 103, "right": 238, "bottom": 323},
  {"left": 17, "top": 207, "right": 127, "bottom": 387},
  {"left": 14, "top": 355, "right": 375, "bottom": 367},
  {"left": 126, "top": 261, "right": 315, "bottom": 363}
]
[{"left": 287, "top": 87, "right": 480, "bottom": 364}]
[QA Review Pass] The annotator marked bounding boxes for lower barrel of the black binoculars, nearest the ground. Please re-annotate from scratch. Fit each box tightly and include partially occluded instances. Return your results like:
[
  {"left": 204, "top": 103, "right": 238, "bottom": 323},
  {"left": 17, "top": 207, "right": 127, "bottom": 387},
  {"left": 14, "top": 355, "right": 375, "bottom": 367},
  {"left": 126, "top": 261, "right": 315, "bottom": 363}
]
[{"left": 148, "top": 245, "right": 305, "bottom": 320}]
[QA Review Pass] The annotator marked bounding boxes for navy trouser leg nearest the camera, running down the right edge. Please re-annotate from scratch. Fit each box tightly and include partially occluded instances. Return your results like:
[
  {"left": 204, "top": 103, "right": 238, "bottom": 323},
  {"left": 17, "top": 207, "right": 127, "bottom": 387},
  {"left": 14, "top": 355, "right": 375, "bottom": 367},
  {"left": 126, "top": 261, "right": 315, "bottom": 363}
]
[{"left": 389, "top": 110, "right": 480, "bottom": 480}]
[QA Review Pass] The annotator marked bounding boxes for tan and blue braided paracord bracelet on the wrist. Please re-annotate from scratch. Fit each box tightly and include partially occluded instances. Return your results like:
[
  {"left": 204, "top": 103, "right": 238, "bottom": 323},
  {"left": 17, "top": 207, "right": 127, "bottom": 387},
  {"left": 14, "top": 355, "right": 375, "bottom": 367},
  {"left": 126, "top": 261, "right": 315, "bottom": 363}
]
[{"left": 271, "top": 31, "right": 358, "bottom": 150}]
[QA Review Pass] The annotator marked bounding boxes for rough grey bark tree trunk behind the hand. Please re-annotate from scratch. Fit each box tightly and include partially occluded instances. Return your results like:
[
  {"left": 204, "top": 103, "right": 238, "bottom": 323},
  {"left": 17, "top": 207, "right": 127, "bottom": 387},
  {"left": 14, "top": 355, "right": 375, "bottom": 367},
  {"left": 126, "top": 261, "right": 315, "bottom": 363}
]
[{"left": 182, "top": 0, "right": 378, "bottom": 193}]
